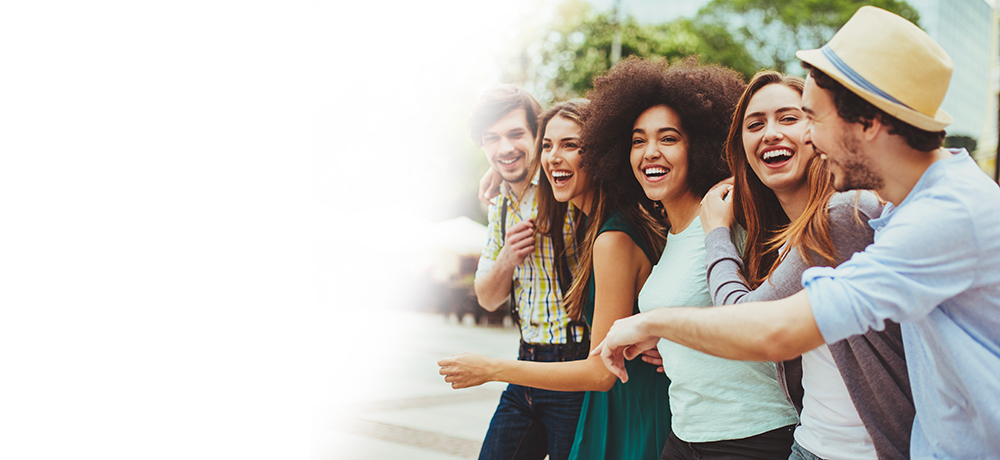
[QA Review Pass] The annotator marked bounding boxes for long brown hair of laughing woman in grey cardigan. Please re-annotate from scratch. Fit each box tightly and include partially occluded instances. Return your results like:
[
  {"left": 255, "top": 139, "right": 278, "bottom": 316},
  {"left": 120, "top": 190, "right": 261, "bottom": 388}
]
[{"left": 726, "top": 70, "right": 836, "bottom": 288}]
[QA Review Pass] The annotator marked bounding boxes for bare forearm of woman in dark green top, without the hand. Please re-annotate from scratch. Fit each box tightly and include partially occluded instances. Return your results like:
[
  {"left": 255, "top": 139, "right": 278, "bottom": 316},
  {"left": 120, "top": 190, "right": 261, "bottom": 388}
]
[{"left": 491, "top": 356, "right": 616, "bottom": 391}]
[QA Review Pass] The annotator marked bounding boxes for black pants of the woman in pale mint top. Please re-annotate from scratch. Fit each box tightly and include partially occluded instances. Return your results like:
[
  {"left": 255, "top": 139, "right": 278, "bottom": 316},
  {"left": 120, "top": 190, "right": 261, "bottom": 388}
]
[{"left": 660, "top": 425, "right": 795, "bottom": 460}]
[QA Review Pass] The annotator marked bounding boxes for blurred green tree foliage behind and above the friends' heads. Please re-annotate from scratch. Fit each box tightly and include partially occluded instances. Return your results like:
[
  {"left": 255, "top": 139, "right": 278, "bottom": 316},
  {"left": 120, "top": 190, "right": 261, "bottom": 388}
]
[{"left": 500, "top": 0, "right": 920, "bottom": 105}]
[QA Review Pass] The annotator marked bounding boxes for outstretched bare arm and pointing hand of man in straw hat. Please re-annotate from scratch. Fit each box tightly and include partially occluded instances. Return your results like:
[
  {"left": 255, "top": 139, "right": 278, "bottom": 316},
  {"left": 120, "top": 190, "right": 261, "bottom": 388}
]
[{"left": 591, "top": 291, "right": 823, "bottom": 382}]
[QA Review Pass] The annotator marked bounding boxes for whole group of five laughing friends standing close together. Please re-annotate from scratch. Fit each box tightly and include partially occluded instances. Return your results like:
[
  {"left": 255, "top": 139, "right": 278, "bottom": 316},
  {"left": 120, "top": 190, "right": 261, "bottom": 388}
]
[{"left": 438, "top": 6, "right": 1000, "bottom": 460}]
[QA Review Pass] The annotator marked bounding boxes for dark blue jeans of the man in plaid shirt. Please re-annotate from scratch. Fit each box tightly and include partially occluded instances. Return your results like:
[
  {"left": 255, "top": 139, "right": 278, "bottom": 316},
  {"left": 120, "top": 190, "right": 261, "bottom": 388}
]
[{"left": 479, "top": 343, "right": 588, "bottom": 460}]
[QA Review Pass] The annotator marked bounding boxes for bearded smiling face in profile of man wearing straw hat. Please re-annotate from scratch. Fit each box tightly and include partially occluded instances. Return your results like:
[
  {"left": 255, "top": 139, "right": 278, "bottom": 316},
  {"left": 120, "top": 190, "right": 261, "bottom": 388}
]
[{"left": 802, "top": 77, "right": 885, "bottom": 191}]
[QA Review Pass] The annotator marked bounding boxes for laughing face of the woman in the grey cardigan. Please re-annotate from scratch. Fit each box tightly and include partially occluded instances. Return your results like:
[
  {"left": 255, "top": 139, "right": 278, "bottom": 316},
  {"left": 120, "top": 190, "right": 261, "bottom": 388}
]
[{"left": 742, "top": 83, "right": 814, "bottom": 194}]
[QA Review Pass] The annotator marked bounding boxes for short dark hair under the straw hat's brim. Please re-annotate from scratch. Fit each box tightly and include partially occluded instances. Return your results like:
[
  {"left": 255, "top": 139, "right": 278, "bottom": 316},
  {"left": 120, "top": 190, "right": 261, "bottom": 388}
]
[{"left": 802, "top": 62, "right": 945, "bottom": 152}]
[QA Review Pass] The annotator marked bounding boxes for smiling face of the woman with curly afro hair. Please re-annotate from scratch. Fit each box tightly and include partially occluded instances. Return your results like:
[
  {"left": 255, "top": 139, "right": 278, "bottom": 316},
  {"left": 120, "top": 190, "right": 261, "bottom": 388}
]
[{"left": 629, "top": 105, "right": 691, "bottom": 202}]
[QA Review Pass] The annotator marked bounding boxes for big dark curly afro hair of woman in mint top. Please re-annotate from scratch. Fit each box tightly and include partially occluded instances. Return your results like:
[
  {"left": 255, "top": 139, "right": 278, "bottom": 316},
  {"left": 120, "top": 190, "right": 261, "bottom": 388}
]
[{"left": 581, "top": 57, "right": 744, "bottom": 212}]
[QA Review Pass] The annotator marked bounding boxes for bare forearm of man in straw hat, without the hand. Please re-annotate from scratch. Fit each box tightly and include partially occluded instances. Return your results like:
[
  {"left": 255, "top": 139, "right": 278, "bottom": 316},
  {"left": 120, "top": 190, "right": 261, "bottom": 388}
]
[{"left": 641, "top": 291, "right": 823, "bottom": 361}]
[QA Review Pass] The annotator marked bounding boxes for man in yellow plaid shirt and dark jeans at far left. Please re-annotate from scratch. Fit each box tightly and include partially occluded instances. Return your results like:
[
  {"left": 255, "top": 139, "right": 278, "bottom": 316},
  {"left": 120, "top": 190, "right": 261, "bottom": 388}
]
[{"left": 460, "top": 85, "right": 589, "bottom": 460}]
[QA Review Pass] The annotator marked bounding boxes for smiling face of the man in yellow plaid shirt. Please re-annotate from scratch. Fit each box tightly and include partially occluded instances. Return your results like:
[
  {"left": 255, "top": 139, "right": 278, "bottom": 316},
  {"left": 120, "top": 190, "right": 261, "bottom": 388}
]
[{"left": 483, "top": 108, "right": 535, "bottom": 187}]
